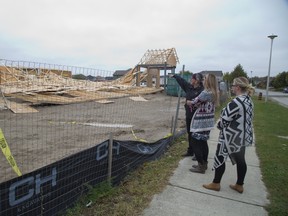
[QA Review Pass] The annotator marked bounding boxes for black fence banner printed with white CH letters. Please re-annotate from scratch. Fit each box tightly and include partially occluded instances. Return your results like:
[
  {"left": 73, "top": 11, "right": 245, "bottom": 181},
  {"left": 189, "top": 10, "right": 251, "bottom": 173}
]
[{"left": 0, "top": 131, "right": 184, "bottom": 216}]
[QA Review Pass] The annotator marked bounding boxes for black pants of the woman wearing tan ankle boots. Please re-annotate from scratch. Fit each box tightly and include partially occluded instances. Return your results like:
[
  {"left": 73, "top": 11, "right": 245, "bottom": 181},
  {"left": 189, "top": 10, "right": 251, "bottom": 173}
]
[{"left": 213, "top": 145, "right": 247, "bottom": 185}]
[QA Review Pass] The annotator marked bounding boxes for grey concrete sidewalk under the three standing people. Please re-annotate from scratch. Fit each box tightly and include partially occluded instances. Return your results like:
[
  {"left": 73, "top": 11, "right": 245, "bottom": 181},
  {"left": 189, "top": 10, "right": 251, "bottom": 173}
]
[{"left": 143, "top": 128, "right": 269, "bottom": 216}]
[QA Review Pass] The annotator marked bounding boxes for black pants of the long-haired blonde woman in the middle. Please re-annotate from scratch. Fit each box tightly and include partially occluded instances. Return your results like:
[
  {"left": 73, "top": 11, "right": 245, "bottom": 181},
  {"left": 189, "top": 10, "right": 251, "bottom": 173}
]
[{"left": 191, "top": 137, "right": 209, "bottom": 164}]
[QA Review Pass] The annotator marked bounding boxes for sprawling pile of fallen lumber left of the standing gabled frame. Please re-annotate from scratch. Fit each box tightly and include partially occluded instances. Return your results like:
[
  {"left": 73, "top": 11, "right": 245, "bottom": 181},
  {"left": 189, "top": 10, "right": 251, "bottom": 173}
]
[{"left": 0, "top": 66, "right": 162, "bottom": 113}]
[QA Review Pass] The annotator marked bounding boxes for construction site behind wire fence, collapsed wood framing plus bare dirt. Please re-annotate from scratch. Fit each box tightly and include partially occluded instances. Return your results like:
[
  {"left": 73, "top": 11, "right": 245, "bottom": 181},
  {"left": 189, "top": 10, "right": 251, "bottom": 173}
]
[{"left": 0, "top": 48, "right": 185, "bottom": 182}]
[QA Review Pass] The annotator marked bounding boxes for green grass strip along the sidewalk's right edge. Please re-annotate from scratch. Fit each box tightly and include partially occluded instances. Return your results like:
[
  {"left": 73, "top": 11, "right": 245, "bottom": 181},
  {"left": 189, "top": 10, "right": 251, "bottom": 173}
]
[{"left": 254, "top": 99, "right": 288, "bottom": 216}]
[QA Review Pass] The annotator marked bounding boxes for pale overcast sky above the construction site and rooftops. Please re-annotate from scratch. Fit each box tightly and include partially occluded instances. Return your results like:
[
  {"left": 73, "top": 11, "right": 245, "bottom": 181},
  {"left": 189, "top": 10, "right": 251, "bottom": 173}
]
[{"left": 0, "top": 0, "right": 288, "bottom": 77}]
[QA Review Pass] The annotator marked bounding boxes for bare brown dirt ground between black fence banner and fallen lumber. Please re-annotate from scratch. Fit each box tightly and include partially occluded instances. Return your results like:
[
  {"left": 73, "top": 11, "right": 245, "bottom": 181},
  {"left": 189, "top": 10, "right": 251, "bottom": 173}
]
[{"left": 0, "top": 92, "right": 185, "bottom": 182}]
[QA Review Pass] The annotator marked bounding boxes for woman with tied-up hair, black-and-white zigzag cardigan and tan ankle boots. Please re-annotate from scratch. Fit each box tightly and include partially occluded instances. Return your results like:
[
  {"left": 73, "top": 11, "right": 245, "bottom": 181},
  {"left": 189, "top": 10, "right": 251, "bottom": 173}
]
[{"left": 203, "top": 77, "right": 254, "bottom": 193}]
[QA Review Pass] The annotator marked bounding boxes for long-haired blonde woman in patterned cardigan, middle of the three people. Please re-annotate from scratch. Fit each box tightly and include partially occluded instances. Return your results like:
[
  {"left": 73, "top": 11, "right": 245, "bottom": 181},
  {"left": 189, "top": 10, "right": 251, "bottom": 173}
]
[{"left": 187, "top": 74, "right": 219, "bottom": 174}]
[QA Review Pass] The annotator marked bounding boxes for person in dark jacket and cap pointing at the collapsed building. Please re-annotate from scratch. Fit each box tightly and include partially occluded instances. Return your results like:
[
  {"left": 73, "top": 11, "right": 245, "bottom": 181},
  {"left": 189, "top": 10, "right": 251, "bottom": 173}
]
[{"left": 172, "top": 73, "right": 204, "bottom": 157}]
